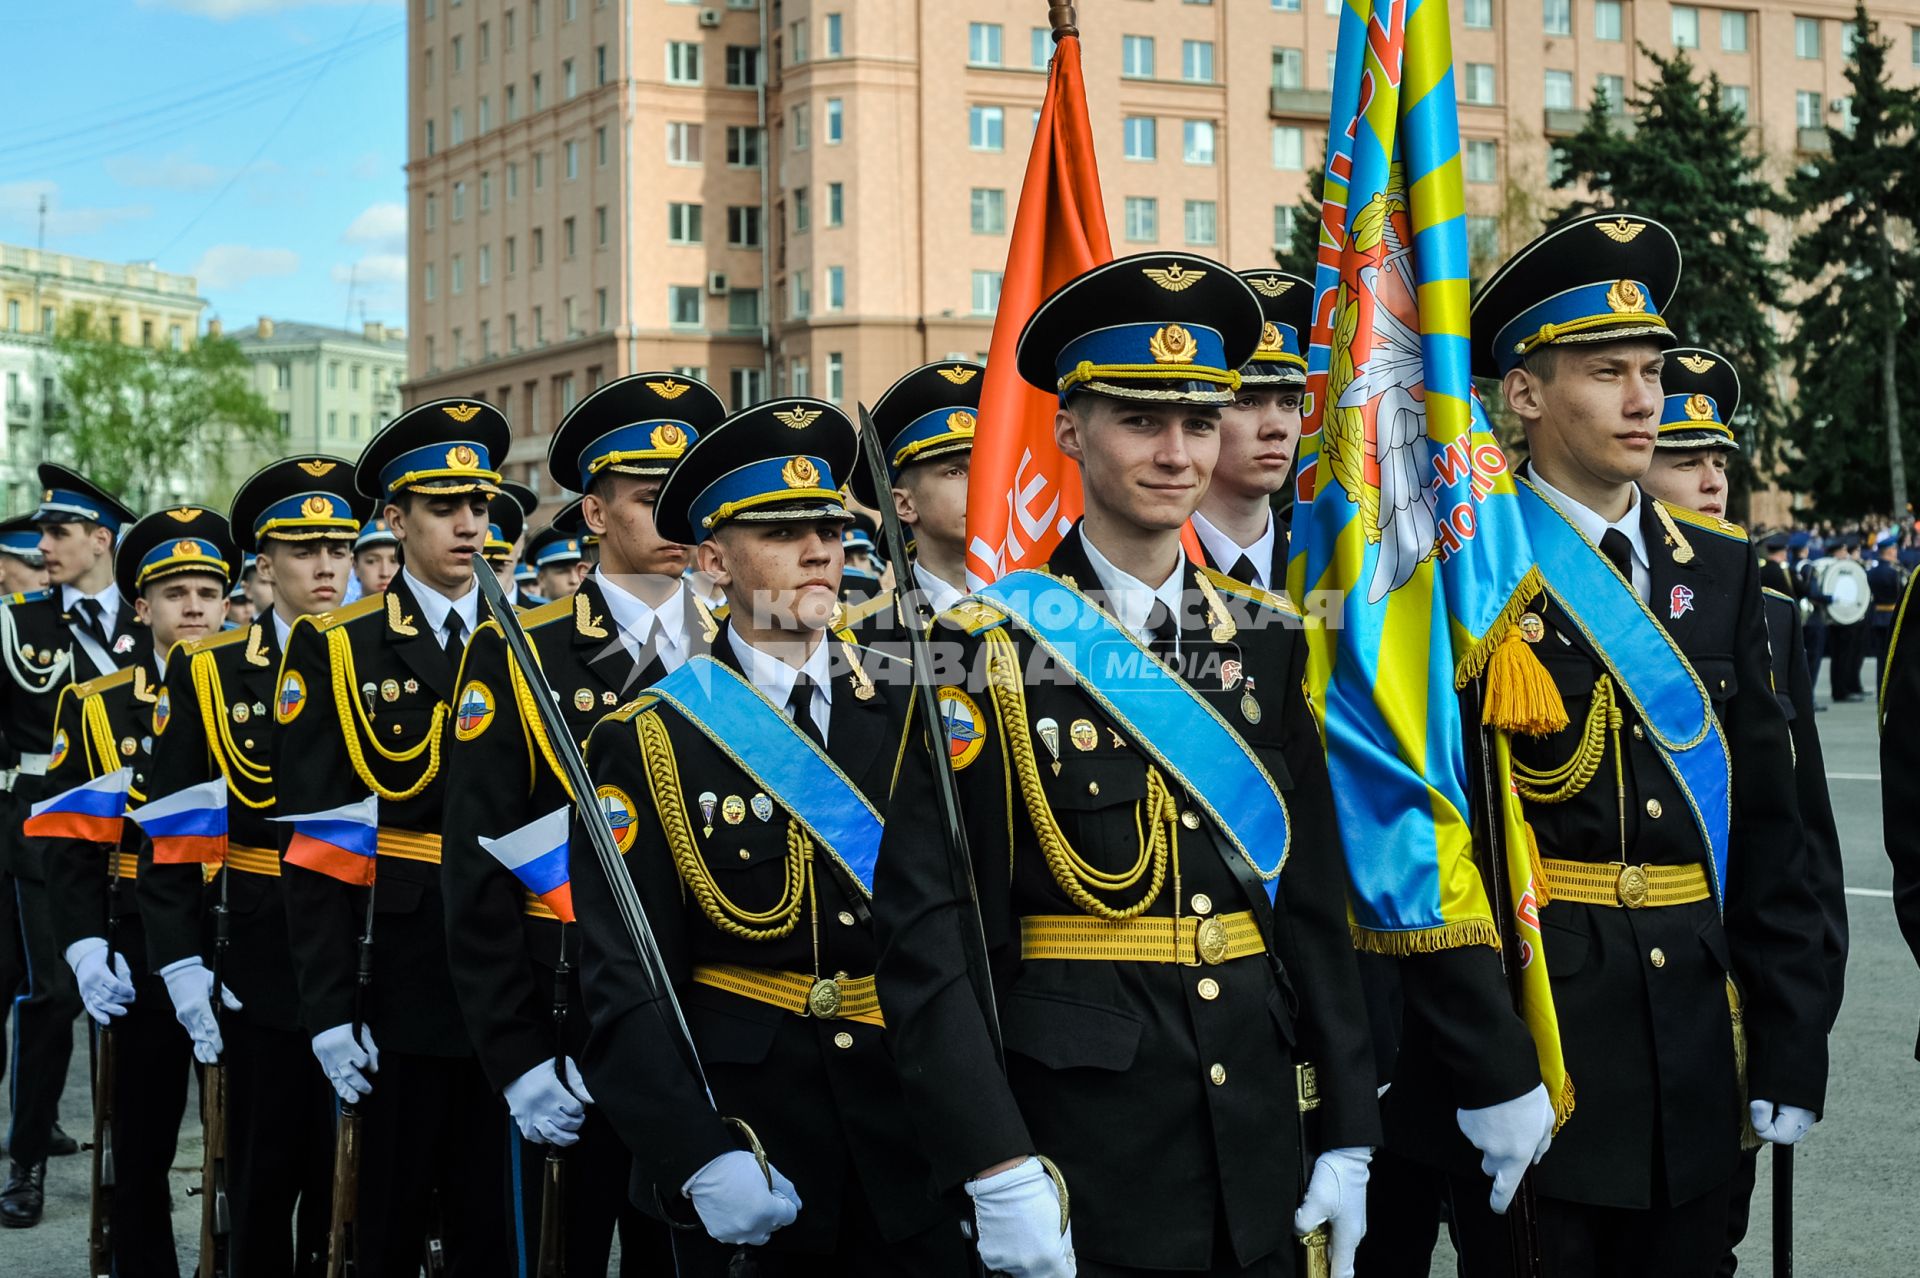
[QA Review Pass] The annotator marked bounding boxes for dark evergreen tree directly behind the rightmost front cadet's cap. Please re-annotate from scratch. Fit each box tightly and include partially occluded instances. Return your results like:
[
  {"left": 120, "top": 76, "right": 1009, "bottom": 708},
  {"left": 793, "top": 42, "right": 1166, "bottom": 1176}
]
[{"left": 1553, "top": 46, "right": 1791, "bottom": 514}]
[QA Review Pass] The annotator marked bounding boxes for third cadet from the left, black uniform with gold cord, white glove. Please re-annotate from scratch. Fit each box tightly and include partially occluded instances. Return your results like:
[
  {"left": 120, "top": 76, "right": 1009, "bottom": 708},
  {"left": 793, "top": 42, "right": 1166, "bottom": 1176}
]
[{"left": 136, "top": 457, "right": 372, "bottom": 1274}]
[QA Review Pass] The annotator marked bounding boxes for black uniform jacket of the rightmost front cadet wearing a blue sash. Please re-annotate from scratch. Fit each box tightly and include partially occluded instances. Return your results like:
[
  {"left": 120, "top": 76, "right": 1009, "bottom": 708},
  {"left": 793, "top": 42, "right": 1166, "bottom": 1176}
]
[{"left": 1386, "top": 485, "right": 1828, "bottom": 1207}]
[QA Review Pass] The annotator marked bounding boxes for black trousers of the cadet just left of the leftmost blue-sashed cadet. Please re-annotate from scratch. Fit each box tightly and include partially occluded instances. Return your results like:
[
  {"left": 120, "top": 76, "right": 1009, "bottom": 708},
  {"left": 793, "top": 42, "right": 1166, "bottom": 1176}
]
[{"left": 513, "top": 1105, "right": 674, "bottom": 1278}]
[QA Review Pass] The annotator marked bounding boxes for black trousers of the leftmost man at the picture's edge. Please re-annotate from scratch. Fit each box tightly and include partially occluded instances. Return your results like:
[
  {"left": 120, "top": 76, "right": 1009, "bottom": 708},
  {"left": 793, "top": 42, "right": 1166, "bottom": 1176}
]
[{"left": 8, "top": 867, "right": 78, "bottom": 1165}]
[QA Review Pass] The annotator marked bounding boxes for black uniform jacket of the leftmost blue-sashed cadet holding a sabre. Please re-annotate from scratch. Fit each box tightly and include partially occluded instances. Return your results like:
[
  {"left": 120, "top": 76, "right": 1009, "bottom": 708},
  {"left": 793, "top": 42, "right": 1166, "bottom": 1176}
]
[{"left": 572, "top": 629, "right": 945, "bottom": 1251}]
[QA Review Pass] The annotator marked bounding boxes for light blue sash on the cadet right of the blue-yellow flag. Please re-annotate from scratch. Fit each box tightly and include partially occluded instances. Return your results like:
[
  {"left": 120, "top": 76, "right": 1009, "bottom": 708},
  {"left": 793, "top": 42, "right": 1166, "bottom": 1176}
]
[{"left": 1519, "top": 476, "right": 1734, "bottom": 908}]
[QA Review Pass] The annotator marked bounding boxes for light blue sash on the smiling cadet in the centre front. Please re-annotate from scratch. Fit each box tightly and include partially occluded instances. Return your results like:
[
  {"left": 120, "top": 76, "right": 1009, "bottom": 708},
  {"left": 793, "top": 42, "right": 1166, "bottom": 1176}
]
[{"left": 973, "top": 568, "right": 1292, "bottom": 902}]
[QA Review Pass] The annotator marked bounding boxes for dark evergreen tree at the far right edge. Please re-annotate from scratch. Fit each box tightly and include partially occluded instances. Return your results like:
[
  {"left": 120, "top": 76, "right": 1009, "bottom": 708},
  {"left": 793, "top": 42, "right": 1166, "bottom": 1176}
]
[{"left": 1788, "top": 4, "right": 1920, "bottom": 518}]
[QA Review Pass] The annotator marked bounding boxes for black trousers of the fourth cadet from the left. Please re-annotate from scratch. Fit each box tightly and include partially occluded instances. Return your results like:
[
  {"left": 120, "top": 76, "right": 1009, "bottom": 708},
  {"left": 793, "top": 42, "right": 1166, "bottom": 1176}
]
[{"left": 345, "top": 1052, "right": 520, "bottom": 1278}]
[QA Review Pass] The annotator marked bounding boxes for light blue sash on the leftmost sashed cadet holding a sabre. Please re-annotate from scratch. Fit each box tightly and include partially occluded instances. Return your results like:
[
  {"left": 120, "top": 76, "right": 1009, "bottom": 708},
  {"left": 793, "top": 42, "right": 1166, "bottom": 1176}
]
[{"left": 641, "top": 656, "right": 881, "bottom": 896}]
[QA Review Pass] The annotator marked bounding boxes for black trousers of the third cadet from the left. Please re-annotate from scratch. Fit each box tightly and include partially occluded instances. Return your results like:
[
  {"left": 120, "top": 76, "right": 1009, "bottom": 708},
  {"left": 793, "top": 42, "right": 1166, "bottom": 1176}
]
[{"left": 221, "top": 1013, "right": 334, "bottom": 1278}]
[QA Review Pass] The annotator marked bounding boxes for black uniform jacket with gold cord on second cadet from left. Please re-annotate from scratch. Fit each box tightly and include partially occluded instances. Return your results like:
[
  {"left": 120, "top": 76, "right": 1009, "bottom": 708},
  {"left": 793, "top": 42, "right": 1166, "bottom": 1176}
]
[{"left": 44, "top": 656, "right": 159, "bottom": 955}]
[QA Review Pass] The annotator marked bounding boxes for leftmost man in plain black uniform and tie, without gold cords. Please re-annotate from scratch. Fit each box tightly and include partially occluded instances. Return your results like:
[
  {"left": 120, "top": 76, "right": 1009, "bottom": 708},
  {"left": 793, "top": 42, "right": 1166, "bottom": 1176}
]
[{"left": 0, "top": 462, "right": 152, "bottom": 1228}]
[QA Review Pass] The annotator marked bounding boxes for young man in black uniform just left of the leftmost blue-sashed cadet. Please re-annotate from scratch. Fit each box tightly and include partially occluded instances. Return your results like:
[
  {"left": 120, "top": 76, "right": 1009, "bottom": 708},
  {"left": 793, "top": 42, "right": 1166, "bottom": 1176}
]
[{"left": 442, "top": 372, "right": 726, "bottom": 1274}]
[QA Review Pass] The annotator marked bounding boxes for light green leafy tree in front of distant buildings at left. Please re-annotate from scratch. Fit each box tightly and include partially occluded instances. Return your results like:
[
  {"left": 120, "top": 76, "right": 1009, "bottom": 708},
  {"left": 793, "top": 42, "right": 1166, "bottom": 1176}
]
[{"left": 46, "top": 311, "right": 278, "bottom": 510}]
